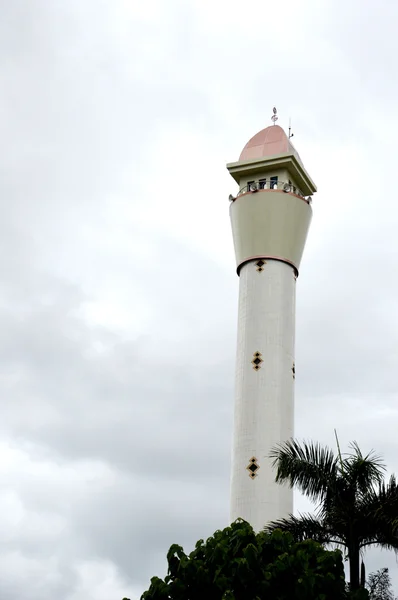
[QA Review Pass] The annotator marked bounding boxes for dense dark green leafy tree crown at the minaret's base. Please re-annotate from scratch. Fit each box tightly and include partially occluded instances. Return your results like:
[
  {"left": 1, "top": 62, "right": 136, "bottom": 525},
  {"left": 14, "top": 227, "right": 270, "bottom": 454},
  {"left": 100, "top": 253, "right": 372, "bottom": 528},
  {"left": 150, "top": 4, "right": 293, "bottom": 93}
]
[{"left": 141, "top": 519, "right": 345, "bottom": 600}]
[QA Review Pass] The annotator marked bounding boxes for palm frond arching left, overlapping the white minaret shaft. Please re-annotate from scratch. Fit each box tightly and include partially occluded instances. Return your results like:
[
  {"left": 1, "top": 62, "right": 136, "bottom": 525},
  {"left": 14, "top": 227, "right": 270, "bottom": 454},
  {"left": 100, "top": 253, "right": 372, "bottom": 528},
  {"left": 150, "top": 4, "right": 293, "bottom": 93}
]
[{"left": 270, "top": 440, "right": 338, "bottom": 501}]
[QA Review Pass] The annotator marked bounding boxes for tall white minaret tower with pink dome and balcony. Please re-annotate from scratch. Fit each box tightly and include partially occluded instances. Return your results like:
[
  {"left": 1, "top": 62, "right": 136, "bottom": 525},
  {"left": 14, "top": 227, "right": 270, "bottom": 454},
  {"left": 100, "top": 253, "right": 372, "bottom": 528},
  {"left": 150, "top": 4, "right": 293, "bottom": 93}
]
[{"left": 227, "top": 109, "right": 316, "bottom": 531}]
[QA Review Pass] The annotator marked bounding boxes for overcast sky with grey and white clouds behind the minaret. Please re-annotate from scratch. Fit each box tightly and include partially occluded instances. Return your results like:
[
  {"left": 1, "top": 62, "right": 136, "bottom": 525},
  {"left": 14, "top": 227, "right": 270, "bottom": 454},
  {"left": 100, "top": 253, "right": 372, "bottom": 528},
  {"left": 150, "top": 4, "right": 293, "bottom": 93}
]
[{"left": 0, "top": 0, "right": 398, "bottom": 600}]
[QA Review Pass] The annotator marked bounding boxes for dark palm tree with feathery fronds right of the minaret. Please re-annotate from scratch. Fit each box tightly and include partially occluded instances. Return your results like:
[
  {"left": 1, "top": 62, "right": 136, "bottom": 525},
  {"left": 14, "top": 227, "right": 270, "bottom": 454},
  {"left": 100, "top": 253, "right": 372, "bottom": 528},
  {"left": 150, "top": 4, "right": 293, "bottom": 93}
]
[{"left": 265, "top": 436, "right": 398, "bottom": 590}]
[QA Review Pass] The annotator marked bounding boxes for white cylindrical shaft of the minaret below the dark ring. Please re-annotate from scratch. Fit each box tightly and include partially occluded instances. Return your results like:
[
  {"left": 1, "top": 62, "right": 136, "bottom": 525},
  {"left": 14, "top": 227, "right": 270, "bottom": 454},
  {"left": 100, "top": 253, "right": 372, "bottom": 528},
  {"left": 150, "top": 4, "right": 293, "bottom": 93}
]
[{"left": 231, "top": 260, "right": 296, "bottom": 531}]
